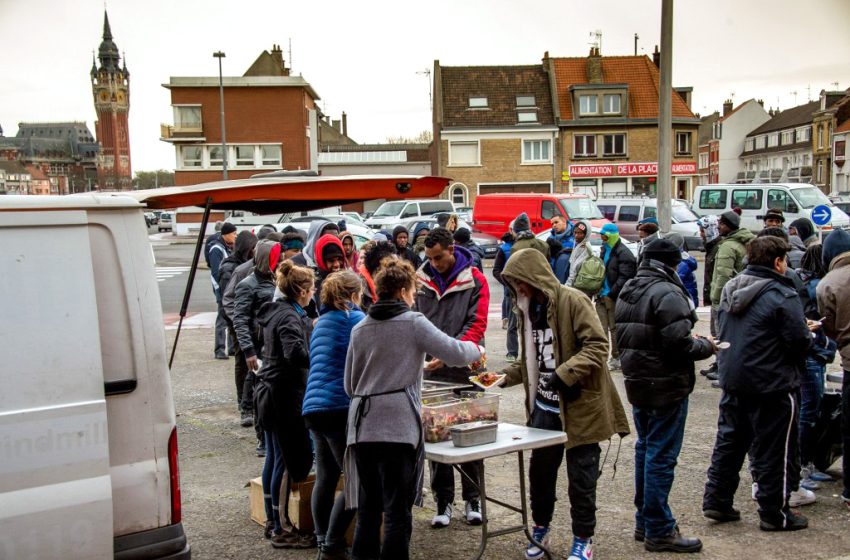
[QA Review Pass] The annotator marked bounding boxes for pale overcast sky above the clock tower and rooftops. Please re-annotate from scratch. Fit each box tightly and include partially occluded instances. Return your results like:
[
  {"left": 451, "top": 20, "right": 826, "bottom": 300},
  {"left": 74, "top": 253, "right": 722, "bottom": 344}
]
[{"left": 0, "top": 0, "right": 850, "bottom": 171}]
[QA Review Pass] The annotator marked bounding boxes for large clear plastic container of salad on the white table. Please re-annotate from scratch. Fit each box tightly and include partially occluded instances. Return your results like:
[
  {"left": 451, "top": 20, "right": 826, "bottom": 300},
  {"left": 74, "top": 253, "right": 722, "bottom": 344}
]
[{"left": 422, "top": 391, "right": 501, "bottom": 443}]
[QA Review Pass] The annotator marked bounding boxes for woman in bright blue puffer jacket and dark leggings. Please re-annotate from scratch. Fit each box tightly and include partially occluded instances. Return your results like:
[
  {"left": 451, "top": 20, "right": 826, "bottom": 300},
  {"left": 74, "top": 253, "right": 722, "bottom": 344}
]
[{"left": 302, "top": 271, "right": 366, "bottom": 558}]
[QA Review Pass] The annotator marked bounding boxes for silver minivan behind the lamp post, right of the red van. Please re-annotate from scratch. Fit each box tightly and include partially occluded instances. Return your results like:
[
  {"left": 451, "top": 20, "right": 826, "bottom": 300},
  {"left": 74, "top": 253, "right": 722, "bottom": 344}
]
[{"left": 596, "top": 196, "right": 703, "bottom": 251}]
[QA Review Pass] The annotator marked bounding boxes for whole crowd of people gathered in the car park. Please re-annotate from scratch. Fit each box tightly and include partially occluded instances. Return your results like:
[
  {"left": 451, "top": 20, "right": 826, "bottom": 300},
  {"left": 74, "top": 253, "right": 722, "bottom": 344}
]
[{"left": 200, "top": 205, "right": 850, "bottom": 560}]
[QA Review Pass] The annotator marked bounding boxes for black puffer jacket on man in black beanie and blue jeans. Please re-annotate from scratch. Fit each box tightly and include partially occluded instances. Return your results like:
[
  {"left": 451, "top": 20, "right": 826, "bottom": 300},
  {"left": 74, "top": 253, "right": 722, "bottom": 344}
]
[{"left": 614, "top": 258, "right": 713, "bottom": 408}]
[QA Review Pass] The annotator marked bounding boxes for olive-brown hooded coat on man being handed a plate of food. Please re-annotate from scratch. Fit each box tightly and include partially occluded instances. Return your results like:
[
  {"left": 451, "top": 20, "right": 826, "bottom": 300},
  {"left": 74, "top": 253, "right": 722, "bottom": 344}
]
[{"left": 502, "top": 250, "right": 629, "bottom": 449}]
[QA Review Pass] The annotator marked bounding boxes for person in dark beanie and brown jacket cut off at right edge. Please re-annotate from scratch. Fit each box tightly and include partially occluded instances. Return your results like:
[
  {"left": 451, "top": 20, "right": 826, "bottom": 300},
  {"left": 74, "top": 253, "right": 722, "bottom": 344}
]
[{"left": 817, "top": 229, "right": 850, "bottom": 509}]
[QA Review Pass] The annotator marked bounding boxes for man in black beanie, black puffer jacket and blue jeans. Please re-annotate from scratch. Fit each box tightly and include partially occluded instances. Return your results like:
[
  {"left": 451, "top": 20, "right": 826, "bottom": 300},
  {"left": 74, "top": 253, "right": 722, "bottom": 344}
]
[{"left": 615, "top": 239, "right": 716, "bottom": 552}]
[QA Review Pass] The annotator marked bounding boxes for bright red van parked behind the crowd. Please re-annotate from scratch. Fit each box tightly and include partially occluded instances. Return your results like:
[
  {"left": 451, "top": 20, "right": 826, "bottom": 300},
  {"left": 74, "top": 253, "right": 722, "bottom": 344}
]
[{"left": 472, "top": 193, "right": 610, "bottom": 237}]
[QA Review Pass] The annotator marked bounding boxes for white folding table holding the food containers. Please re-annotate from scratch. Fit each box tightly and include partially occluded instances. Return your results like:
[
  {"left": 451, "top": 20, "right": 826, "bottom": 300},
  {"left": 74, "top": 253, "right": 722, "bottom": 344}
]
[{"left": 425, "top": 422, "right": 567, "bottom": 560}]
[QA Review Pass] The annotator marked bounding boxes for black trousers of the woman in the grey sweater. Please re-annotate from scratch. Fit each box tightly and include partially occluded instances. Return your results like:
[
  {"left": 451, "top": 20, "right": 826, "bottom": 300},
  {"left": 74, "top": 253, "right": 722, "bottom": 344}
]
[{"left": 351, "top": 443, "right": 416, "bottom": 560}]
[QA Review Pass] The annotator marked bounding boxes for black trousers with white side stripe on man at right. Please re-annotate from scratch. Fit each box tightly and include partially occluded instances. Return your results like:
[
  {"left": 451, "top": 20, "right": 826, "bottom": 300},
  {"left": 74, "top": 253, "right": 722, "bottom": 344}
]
[{"left": 702, "top": 391, "right": 800, "bottom": 524}]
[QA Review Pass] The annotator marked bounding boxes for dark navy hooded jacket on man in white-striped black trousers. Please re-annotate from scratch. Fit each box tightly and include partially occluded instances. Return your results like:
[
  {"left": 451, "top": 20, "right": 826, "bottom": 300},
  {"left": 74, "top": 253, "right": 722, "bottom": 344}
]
[{"left": 717, "top": 265, "right": 812, "bottom": 394}]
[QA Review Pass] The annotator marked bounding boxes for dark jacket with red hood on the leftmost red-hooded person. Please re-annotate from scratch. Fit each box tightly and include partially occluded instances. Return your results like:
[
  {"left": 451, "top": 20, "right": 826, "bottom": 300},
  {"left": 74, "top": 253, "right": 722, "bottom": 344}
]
[{"left": 233, "top": 240, "right": 278, "bottom": 358}]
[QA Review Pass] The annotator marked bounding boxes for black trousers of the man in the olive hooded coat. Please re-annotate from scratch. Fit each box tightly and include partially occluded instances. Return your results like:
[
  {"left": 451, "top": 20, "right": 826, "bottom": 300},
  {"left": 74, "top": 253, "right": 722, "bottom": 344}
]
[{"left": 528, "top": 407, "right": 600, "bottom": 538}]
